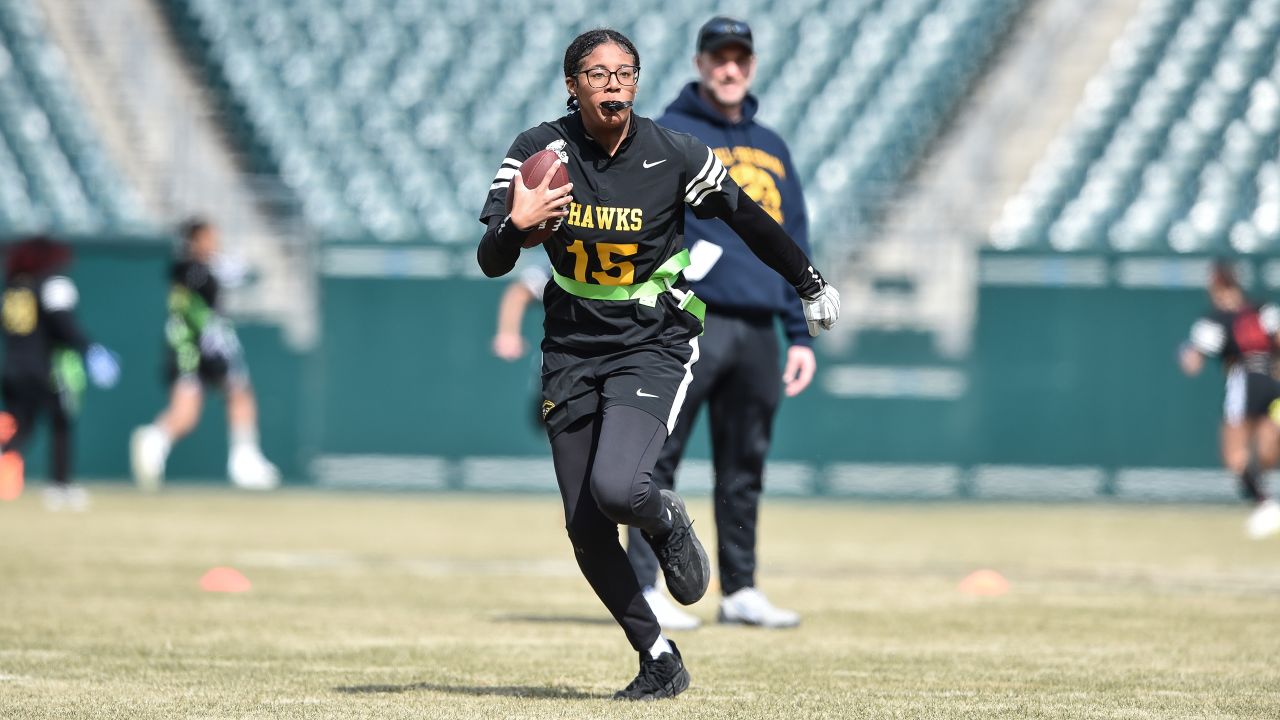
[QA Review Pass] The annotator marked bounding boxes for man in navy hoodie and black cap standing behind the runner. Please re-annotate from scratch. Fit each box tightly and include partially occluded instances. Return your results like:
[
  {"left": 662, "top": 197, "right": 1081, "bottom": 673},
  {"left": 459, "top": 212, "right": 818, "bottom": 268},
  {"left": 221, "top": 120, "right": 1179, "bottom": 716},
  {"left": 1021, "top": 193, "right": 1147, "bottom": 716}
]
[{"left": 627, "top": 17, "right": 817, "bottom": 629}]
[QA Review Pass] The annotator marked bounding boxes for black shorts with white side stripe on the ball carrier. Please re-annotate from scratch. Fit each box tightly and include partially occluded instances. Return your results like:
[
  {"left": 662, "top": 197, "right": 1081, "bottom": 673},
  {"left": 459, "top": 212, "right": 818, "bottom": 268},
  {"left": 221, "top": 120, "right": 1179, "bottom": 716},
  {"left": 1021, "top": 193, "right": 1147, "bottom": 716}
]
[{"left": 541, "top": 337, "right": 698, "bottom": 437}]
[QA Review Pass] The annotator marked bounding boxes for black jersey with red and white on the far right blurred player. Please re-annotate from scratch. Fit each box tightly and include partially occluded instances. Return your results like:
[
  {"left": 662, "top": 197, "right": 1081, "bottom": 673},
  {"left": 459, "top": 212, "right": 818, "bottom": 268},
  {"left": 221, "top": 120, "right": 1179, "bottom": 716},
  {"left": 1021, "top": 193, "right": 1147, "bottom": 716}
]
[{"left": 1190, "top": 305, "right": 1280, "bottom": 374}]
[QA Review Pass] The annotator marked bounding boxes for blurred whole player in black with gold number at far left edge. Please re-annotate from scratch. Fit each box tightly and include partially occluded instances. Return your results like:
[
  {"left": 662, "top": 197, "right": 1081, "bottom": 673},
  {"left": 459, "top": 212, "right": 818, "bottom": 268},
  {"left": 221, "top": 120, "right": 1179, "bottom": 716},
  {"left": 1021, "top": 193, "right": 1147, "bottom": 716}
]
[{"left": 0, "top": 237, "right": 120, "bottom": 510}]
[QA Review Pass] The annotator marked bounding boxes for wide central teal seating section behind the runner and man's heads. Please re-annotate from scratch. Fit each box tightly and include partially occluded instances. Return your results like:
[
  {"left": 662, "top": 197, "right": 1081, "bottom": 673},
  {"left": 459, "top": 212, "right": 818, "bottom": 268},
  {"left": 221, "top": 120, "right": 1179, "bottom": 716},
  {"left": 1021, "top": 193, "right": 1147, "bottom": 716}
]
[{"left": 163, "top": 0, "right": 1023, "bottom": 242}]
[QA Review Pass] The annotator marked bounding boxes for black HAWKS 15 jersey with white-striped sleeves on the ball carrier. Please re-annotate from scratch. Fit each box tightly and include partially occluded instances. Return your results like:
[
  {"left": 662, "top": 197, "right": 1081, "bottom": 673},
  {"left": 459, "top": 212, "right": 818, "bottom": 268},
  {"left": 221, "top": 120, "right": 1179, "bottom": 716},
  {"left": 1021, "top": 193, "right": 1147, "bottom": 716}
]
[{"left": 480, "top": 113, "right": 740, "bottom": 352}]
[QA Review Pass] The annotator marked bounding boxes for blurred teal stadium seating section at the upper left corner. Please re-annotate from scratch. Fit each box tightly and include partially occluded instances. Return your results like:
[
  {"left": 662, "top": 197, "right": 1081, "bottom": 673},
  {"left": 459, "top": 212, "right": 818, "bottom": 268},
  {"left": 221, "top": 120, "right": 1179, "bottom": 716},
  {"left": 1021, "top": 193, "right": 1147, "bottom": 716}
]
[{"left": 0, "top": 1, "right": 143, "bottom": 234}]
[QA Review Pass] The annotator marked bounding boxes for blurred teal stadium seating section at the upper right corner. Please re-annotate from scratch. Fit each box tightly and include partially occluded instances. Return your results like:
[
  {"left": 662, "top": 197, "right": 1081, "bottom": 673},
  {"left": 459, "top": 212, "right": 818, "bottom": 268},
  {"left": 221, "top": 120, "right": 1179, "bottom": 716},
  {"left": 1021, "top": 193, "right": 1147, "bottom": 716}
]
[{"left": 991, "top": 0, "right": 1280, "bottom": 252}]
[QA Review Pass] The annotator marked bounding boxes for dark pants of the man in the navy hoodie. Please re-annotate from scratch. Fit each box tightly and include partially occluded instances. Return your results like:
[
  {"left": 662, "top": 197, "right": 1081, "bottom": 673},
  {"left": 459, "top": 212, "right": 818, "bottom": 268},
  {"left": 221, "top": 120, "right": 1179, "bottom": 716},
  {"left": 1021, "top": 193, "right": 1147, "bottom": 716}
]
[{"left": 627, "top": 310, "right": 782, "bottom": 594}]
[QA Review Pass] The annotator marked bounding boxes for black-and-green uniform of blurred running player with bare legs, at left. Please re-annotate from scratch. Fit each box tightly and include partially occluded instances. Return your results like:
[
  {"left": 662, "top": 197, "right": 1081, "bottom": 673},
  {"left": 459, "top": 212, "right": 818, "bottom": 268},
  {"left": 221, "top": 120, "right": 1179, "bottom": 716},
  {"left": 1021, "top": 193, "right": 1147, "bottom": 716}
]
[{"left": 165, "top": 259, "right": 248, "bottom": 387}]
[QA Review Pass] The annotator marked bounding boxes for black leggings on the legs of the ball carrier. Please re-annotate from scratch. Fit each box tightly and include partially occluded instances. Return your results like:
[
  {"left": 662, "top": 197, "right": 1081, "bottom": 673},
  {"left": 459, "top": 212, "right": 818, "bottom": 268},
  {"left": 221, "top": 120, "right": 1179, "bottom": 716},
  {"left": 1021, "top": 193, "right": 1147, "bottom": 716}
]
[{"left": 552, "top": 405, "right": 671, "bottom": 651}]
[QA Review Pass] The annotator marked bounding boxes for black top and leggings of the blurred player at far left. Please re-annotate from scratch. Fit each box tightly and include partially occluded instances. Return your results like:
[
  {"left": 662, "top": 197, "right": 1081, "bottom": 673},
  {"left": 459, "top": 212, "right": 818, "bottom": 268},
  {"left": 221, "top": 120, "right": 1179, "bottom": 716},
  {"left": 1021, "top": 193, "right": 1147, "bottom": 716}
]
[{"left": 0, "top": 275, "right": 88, "bottom": 483}]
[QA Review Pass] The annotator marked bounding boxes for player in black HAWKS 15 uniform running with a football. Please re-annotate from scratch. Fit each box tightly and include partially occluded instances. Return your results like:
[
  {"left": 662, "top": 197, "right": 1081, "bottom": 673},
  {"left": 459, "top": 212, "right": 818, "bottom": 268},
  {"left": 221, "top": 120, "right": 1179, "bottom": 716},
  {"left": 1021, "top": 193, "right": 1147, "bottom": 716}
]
[{"left": 477, "top": 29, "right": 840, "bottom": 700}]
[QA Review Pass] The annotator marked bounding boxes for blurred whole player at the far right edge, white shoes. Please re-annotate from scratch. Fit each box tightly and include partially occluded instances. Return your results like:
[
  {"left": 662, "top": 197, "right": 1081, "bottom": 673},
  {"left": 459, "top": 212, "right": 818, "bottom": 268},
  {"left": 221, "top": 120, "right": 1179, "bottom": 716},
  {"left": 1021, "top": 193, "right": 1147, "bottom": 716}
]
[{"left": 1179, "top": 261, "right": 1280, "bottom": 538}]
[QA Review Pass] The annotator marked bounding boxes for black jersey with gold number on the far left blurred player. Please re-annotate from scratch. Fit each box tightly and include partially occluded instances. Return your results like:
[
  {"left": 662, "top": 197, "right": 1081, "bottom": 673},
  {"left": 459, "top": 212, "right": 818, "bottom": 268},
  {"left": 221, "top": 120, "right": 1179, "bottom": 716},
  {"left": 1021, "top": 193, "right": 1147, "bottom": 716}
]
[{"left": 0, "top": 275, "right": 88, "bottom": 382}]
